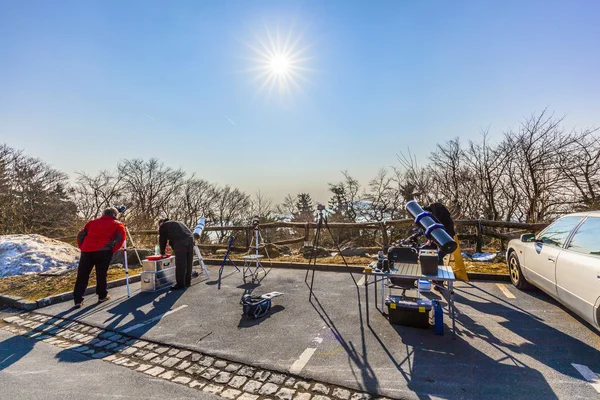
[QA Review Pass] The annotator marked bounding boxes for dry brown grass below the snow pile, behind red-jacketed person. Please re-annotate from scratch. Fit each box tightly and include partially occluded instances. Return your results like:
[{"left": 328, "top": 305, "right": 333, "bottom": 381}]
[{"left": 0, "top": 267, "right": 142, "bottom": 300}]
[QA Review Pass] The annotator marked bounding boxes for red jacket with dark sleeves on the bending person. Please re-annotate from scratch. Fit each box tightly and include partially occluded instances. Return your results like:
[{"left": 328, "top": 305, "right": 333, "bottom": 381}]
[{"left": 77, "top": 215, "right": 125, "bottom": 253}]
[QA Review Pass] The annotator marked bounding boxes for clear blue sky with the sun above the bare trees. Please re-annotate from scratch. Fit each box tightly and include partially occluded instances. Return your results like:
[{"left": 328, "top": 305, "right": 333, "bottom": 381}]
[{"left": 0, "top": 0, "right": 600, "bottom": 202}]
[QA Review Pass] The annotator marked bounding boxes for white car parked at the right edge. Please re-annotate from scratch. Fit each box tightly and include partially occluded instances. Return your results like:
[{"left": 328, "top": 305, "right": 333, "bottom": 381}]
[{"left": 506, "top": 211, "right": 600, "bottom": 330}]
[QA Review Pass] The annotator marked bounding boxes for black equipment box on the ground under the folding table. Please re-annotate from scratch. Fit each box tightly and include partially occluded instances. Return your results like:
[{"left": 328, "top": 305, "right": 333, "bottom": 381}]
[{"left": 385, "top": 296, "right": 432, "bottom": 329}]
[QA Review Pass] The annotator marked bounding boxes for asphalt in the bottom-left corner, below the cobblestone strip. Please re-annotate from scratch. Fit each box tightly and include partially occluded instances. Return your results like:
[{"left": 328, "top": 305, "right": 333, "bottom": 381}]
[{"left": 0, "top": 330, "right": 219, "bottom": 400}]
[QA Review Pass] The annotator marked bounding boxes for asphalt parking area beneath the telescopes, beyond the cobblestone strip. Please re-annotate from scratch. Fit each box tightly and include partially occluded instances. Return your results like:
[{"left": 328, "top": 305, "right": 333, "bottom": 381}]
[{"left": 24, "top": 267, "right": 600, "bottom": 399}]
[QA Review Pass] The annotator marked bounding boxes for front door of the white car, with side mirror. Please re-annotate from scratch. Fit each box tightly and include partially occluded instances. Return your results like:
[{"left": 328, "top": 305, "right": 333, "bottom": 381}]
[{"left": 524, "top": 216, "right": 582, "bottom": 298}]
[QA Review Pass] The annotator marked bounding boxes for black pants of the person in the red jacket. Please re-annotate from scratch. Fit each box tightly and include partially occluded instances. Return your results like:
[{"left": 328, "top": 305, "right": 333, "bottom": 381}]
[{"left": 73, "top": 250, "right": 112, "bottom": 303}]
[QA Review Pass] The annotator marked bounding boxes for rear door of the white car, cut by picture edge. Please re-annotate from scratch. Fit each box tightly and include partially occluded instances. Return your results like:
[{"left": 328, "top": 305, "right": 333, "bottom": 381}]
[{"left": 556, "top": 217, "right": 600, "bottom": 325}]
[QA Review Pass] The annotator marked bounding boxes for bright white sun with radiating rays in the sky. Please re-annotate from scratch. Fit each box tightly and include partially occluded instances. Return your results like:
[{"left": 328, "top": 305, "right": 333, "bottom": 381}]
[{"left": 248, "top": 28, "right": 311, "bottom": 96}]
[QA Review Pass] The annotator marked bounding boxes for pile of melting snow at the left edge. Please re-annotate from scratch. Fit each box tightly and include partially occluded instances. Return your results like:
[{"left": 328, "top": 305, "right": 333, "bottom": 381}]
[{"left": 0, "top": 235, "right": 79, "bottom": 277}]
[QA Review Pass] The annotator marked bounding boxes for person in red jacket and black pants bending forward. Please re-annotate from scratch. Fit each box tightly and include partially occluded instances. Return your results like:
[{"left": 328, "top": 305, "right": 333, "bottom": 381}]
[{"left": 73, "top": 207, "right": 125, "bottom": 308}]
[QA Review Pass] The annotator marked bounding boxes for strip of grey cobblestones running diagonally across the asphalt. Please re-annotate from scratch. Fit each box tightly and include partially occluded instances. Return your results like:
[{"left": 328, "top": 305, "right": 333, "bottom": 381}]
[{"left": 0, "top": 310, "right": 387, "bottom": 400}]
